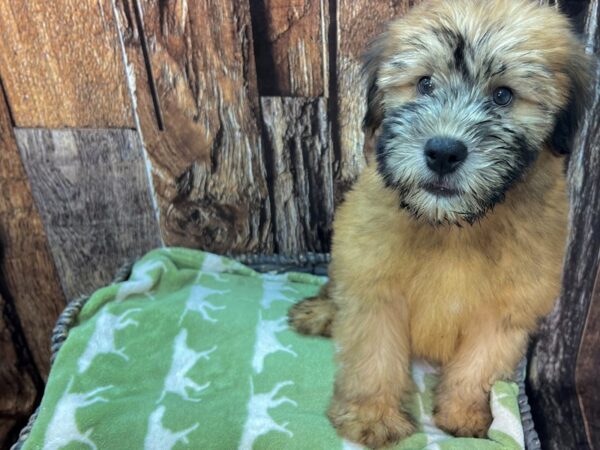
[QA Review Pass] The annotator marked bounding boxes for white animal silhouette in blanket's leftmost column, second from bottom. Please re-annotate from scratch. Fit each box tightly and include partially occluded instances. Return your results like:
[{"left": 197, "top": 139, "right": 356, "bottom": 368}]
[{"left": 77, "top": 308, "right": 140, "bottom": 373}]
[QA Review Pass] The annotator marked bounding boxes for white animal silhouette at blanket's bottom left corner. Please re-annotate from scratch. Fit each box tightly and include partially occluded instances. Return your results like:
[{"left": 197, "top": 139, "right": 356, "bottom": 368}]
[{"left": 43, "top": 378, "right": 112, "bottom": 450}]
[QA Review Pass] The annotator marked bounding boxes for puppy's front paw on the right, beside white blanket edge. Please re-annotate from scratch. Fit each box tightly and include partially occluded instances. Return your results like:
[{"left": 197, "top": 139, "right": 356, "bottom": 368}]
[{"left": 434, "top": 395, "right": 492, "bottom": 437}]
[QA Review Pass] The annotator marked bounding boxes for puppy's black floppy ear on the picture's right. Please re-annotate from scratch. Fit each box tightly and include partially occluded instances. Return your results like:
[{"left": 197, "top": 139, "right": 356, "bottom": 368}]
[{"left": 549, "top": 49, "right": 591, "bottom": 155}]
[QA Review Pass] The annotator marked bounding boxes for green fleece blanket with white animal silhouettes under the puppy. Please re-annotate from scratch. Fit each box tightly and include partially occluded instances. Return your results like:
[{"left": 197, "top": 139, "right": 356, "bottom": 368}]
[{"left": 24, "top": 248, "right": 523, "bottom": 450}]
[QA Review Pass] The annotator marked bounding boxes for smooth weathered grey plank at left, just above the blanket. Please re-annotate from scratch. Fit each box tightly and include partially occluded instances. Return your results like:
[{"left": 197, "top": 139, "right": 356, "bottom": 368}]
[{"left": 15, "top": 129, "right": 160, "bottom": 298}]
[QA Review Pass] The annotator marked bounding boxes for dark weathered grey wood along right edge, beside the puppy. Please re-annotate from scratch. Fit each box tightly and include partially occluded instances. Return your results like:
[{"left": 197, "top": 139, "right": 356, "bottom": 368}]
[{"left": 529, "top": 0, "right": 600, "bottom": 450}]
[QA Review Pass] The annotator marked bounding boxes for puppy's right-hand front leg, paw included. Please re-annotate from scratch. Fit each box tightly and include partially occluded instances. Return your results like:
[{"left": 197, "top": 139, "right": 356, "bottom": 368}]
[{"left": 434, "top": 320, "right": 528, "bottom": 437}]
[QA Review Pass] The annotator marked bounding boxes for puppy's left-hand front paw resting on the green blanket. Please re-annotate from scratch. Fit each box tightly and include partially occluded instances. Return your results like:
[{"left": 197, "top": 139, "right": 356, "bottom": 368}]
[{"left": 327, "top": 398, "right": 415, "bottom": 448}]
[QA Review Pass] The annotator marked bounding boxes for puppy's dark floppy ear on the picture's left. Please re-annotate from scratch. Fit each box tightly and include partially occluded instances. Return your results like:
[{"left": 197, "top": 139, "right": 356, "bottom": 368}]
[{"left": 362, "top": 32, "right": 387, "bottom": 134}]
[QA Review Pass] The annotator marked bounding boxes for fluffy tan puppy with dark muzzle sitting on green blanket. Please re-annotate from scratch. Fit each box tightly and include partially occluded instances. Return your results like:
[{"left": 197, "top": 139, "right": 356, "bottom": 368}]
[{"left": 289, "top": 0, "right": 589, "bottom": 447}]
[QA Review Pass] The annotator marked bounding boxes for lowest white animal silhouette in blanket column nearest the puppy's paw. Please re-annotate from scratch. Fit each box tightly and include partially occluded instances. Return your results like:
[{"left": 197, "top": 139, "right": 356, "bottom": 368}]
[{"left": 238, "top": 378, "right": 298, "bottom": 450}]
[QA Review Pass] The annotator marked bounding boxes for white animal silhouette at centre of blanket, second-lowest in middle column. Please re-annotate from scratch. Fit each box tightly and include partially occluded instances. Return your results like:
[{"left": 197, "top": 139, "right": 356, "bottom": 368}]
[{"left": 156, "top": 329, "right": 217, "bottom": 403}]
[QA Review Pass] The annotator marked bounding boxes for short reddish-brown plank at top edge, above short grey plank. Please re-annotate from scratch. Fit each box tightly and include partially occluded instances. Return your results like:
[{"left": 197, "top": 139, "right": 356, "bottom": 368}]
[{"left": 250, "top": 0, "right": 328, "bottom": 97}]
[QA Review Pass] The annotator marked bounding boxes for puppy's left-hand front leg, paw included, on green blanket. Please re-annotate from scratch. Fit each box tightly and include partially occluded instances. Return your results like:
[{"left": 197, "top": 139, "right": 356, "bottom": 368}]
[{"left": 328, "top": 291, "right": 414, "bottom": 448}]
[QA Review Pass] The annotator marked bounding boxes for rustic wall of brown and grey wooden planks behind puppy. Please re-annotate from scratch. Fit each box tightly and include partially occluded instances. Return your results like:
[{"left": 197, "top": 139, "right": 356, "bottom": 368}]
[{"left": 0, "top": 0, "right": 600, "bottom": 449}]
